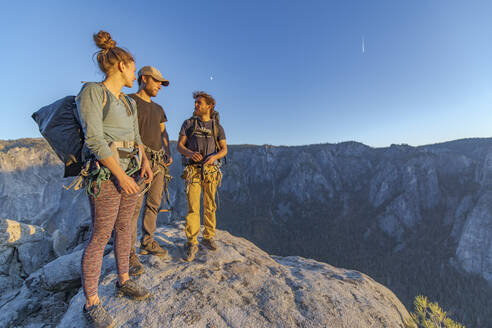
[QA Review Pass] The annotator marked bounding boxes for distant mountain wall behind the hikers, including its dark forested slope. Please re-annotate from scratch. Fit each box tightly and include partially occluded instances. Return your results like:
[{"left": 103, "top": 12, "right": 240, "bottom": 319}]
[{"left": 0, "top": 139, "right": 492, "bottom": 326}]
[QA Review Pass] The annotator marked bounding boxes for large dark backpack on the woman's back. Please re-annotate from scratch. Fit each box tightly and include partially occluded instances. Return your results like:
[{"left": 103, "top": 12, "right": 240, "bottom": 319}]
[{"left": 32, "top": 83, "right": 134, "bottom": 178}]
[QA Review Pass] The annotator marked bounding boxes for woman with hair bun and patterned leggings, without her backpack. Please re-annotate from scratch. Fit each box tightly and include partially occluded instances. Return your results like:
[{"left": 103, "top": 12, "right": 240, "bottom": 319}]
[{"left": 76, "top": 31, "right": 152, "bottom": 328}]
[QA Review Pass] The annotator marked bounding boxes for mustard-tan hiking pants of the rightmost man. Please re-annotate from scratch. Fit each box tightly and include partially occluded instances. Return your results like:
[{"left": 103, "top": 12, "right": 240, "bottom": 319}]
[{"left": 183, "top": 165, "right": 222, "bottom": 245}]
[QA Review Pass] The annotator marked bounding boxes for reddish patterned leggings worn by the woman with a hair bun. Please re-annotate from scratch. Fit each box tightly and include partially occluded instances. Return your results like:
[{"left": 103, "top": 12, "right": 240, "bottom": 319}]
[{"left": 82, "top": 179, "right": 138, "bottom": 297}]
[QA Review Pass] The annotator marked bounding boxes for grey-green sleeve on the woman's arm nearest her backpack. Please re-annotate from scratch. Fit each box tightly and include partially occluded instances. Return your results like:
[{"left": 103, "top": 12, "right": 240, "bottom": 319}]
[{"left": 76, "top": 83, "right": 112, "bottom": 160}]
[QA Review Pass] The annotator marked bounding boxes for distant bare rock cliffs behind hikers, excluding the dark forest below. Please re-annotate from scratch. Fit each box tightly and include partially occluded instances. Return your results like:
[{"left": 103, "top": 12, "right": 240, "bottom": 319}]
[{"left": 0, "top": 139, "right": 492, "bottom": 280}]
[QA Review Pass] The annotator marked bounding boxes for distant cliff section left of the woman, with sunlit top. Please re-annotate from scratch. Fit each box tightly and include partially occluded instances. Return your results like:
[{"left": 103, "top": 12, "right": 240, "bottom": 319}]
[{"left": 0, "top": 139, "right": 90, "bottom": 252}]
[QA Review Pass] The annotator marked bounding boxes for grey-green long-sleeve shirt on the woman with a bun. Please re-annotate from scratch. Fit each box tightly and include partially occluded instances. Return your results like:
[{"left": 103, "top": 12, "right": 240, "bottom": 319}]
[{"left": 76, "top": 82, "right": 142, "bottom": 170}]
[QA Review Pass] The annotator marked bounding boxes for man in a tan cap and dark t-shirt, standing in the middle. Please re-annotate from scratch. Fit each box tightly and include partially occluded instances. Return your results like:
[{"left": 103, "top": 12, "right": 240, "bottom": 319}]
[{"left": 129, "top": 66, "right": 172, "bottom": 276}]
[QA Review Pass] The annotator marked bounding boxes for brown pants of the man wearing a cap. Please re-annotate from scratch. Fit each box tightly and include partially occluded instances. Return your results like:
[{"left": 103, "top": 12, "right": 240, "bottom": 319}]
[{"left": 132, "top": 164, "right": 165, "bottom": 253}]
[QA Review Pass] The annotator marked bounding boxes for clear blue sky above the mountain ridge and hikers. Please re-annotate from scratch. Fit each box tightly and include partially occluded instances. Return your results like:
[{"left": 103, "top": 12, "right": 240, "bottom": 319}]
[{"left": 0, "top": 0, "right": 492, "bottom": 147}]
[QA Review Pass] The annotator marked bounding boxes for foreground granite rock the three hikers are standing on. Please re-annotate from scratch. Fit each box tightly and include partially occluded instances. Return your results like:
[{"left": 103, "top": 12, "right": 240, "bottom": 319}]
[{"left": 0, "top": 221, "right": 409, "bottom": 328}]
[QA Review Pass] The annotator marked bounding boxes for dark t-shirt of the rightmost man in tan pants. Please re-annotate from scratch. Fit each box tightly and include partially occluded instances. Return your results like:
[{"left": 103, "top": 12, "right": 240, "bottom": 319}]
[{"left": 179, "top": 118, "right": 225, "bottom": 158}]
